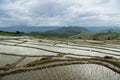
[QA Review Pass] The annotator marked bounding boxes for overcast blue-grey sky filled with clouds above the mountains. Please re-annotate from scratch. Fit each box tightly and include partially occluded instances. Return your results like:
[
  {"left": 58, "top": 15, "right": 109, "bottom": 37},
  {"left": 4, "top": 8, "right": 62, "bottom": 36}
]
[{"left": 0, "top": 0, "right": 120, "bottom": 27}]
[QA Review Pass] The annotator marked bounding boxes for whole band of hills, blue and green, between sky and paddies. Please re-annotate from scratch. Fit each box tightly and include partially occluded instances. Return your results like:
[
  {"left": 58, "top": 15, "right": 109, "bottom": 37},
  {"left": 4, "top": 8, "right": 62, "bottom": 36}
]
[{"left": 0, "top": 26, "right": 120, "bottom": 40}]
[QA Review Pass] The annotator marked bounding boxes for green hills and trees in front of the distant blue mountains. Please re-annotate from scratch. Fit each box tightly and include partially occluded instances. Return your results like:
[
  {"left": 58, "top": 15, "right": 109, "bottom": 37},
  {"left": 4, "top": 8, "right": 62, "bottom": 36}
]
[{"left": 0, "top": 27, "right": 120, "bottom": 41}]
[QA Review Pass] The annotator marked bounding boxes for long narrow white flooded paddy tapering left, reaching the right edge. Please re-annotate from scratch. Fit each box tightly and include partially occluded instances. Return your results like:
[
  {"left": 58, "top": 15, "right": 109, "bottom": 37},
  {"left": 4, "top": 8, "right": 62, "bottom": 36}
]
[{"left": 20, "top": 44, "right": 120, "bottom": 58}]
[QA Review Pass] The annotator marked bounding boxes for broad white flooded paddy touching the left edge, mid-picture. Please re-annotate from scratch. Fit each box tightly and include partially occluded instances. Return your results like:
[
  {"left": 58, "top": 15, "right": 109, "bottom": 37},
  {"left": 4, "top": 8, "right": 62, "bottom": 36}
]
[{"left": 0, "top": 45, "right": 56, "bottom": 55}]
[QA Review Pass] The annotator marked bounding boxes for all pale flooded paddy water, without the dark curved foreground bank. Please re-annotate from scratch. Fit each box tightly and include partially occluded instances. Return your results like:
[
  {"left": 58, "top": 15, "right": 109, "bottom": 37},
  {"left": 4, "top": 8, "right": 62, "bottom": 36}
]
[{"left": 0, "top": 37, "right": 120, "bottom": 80}]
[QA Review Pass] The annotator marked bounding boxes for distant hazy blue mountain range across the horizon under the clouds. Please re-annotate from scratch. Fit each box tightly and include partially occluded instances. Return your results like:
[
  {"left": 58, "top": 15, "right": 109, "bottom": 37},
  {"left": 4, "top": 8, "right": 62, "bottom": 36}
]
[{"left": 0, "top": 25, "right": 120, "bottom": 32}]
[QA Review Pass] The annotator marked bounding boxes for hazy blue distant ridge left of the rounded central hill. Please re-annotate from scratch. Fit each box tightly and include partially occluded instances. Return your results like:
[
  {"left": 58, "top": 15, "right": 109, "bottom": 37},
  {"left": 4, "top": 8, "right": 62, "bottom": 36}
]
[{"left": 0, "top": 25, "right": 59, "bottom": 32}]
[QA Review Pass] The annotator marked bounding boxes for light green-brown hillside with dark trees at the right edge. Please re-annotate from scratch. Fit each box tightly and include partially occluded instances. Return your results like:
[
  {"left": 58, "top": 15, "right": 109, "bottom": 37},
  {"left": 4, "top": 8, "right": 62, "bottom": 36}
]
[{"left": 70, "top": 31, "right": 120, "bottom": 40}]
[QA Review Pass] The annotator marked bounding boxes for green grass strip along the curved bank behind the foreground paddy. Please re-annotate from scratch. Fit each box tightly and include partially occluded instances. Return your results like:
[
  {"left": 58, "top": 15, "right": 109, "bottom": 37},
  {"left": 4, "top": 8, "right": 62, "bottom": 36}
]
[{"left": 25, "top": 57, "right": 120, "bottom": 67}]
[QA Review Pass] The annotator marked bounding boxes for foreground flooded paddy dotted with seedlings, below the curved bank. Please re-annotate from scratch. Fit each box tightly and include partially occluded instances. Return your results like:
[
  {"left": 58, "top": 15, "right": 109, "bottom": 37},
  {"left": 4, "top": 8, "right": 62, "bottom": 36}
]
[{"left": 2, "top": 64, "right": 120, "bottom": 80}]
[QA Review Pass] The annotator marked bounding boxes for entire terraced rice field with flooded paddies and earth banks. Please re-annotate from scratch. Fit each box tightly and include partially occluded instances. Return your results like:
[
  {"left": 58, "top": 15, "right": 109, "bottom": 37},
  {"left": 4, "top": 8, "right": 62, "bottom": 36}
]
[{"left": 0, "top": 36, "right": 120, "bottom": 80}]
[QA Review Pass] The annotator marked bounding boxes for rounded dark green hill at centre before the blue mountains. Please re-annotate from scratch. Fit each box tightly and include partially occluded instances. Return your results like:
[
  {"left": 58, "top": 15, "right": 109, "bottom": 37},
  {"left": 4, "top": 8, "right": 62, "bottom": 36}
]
[{"left": 38, "top": 27, "right": 88, "bottom": 37}]
